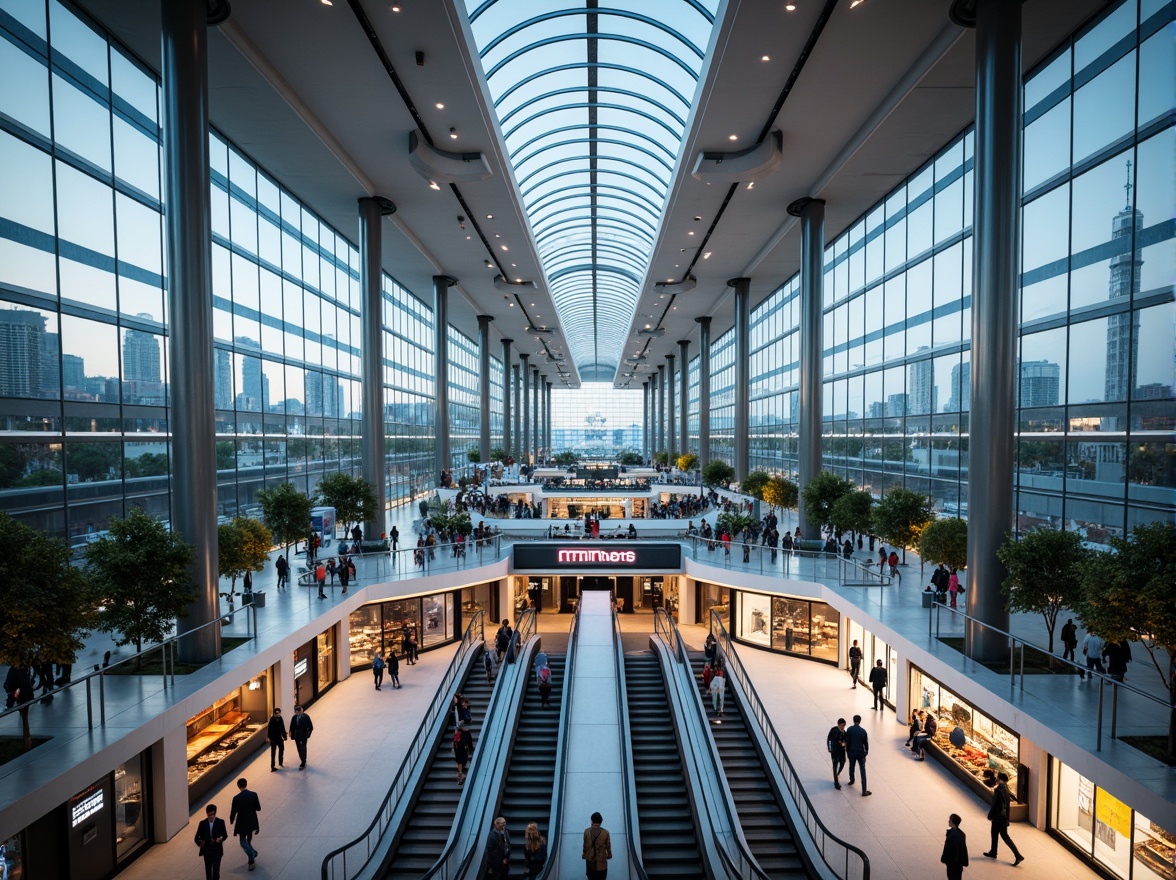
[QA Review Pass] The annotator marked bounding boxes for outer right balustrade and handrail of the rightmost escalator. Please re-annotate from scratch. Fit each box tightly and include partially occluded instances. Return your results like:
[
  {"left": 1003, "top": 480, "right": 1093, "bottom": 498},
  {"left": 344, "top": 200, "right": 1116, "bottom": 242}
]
[{"left": 710, "top": 611, "right": 870, "bottom": 880}]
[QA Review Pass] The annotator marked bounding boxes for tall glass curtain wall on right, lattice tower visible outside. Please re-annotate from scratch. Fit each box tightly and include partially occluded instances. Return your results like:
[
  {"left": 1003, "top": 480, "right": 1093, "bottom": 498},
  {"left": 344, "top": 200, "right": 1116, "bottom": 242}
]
[{"left": 733, "top": 0, "right": 1176, "bottom": 544}]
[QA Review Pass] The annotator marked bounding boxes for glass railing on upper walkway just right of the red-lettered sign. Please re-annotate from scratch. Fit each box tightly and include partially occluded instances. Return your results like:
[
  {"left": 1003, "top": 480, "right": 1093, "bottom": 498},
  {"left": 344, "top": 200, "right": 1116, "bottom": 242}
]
[{"left": 686, "top": 535, "right": 891, "bottom": 587}]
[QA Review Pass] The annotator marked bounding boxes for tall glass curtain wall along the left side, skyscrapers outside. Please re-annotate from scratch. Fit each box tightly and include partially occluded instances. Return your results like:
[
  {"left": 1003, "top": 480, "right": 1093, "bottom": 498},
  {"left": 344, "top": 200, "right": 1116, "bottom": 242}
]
[{"left": 0, "top": 0, "right": 434, "bottom": 547}]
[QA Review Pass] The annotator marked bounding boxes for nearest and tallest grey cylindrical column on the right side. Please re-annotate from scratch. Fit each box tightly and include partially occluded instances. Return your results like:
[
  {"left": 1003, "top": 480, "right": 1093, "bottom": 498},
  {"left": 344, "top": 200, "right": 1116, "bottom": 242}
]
[{"left": 964, "top": 0, "right": 1022, "bottom": 660}]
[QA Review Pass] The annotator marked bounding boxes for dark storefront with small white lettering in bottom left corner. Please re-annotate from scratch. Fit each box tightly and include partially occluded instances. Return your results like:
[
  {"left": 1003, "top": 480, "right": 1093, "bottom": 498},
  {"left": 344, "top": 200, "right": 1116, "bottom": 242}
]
[{"left": 0, "top": 752, "right": 152, "bottom": 880}]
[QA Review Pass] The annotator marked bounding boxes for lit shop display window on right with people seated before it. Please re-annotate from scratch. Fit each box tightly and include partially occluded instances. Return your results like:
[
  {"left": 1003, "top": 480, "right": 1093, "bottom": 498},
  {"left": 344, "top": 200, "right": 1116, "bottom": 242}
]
[{"left": 907, "top": 667, "right": 1029, "bottom": 821}]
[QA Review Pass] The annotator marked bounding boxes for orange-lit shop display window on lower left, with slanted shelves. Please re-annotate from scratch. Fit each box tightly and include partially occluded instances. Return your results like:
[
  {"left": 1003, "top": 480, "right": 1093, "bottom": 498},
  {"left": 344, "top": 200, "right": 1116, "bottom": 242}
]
[{"left": 187, "top": 668, "right": 272, "bottom": 804}]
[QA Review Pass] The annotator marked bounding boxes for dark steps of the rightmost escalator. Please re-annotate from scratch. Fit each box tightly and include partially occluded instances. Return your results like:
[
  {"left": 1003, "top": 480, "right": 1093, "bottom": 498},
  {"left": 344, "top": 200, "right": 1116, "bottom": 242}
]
[{"left": 691, "top": 652, "right": 810, "bottom": 878}]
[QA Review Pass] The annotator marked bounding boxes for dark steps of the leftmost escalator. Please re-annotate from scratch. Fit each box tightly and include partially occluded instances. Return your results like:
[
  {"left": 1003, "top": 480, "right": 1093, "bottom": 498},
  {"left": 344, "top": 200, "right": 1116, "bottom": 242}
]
[{"left": 383, "top": 647, "right": 493, "bottom": 880}]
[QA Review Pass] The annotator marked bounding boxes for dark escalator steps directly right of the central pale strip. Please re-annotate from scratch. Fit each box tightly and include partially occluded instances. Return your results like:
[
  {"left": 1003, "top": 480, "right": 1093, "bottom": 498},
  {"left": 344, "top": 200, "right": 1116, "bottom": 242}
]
[{"left": 624, "top": 653, "right": 707, "bottom": 880}]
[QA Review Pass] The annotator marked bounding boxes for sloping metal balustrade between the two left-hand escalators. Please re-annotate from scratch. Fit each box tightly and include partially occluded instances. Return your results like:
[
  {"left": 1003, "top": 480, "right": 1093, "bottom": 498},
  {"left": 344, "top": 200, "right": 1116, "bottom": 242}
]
[{"left": 421, "top": 609, "right": 535, "bottom": 880}]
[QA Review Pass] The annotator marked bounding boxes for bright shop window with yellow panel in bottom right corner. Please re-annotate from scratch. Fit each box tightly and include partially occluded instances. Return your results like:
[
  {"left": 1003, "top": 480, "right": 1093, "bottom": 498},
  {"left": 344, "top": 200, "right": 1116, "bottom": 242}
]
[{"left": 1049, "top": 758, "right": 1176, "bottom": 880}]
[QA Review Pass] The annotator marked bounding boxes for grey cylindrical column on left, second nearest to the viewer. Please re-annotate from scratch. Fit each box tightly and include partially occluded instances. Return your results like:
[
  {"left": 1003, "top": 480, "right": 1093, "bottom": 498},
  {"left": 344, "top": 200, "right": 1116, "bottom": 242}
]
[{"left": 359, "top": 198, "right": 395, "bottom": 538}]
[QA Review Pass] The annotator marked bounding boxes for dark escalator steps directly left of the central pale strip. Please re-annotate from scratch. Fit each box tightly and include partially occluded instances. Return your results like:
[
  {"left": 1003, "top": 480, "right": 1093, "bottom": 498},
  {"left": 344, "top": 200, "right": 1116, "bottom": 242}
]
[{"left": 497, "top": 654, "right": 567, "bottom": 876}]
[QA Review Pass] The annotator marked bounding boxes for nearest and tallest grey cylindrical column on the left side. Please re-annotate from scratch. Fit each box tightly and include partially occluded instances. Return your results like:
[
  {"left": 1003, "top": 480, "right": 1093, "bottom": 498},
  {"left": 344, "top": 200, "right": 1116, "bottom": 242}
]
[{"left": 162, "top": 0, "right": 220, "bottom": 662}]
